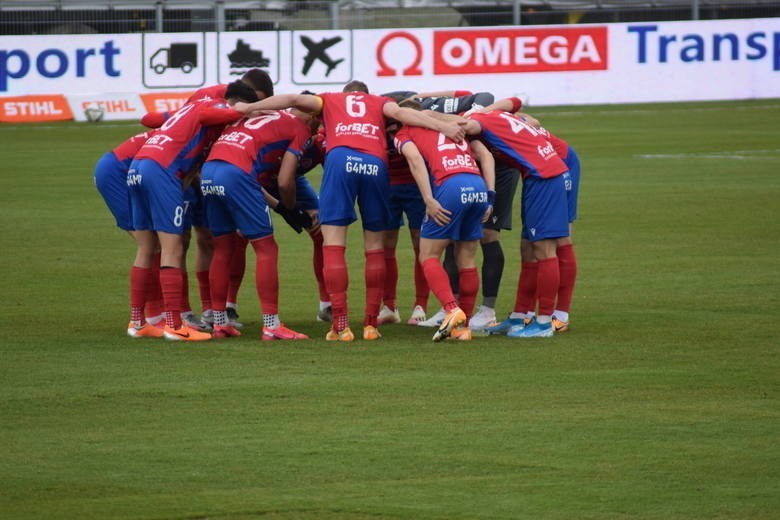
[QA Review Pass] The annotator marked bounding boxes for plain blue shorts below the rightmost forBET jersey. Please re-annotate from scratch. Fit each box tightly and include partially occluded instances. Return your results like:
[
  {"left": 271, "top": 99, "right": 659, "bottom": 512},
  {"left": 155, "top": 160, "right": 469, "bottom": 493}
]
[{"left": 521, "top": 172, "right": 569, "bottom": 242}]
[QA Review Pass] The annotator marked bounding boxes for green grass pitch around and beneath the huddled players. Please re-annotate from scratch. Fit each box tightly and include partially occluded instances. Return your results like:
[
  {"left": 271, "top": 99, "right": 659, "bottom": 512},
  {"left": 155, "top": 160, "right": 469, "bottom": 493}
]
[{"left": 0, "top": 100, "right": 780, "bottom": 520}]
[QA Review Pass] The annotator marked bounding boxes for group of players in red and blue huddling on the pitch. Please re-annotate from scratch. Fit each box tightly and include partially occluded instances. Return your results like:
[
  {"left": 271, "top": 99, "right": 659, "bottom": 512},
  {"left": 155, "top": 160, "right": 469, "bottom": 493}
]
[{"left": 95, "top": 69, "right": 580, "bottom": 342}]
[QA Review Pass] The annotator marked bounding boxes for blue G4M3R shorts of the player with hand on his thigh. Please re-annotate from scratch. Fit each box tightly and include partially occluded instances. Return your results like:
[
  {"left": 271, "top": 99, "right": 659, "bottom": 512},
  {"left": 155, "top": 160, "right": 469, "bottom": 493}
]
[{"left": 420, "top": 173, "right": 488, "bottom": 242}]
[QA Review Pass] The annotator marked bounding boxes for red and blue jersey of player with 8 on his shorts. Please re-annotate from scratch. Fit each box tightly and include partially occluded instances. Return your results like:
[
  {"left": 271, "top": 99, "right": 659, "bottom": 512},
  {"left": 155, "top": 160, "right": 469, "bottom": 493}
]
[{"left": 136, "top": 99, "right": 243, "bottom": 177}]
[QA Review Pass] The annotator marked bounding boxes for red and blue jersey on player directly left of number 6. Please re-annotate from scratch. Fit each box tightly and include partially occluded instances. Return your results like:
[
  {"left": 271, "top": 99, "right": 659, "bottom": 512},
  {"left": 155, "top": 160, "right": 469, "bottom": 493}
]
[{"left": 207, "top": 110, "right": 311, "bottom": 186}]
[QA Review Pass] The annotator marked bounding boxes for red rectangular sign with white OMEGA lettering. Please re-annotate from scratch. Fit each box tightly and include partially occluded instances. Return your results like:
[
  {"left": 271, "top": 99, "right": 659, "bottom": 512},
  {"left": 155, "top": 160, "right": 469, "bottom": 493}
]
[{"left": 433, "top": 27, "right": 607, "bottom": 74}]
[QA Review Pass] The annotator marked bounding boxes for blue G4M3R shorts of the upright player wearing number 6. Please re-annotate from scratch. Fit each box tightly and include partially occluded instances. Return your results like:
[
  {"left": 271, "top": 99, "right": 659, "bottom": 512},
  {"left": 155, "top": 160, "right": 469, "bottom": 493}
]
[{"left": 320, "top": 146, "right": 390, "bottom": 231}]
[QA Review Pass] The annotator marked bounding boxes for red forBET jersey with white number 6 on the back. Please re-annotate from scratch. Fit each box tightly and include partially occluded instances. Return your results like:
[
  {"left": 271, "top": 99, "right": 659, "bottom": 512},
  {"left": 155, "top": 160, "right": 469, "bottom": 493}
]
[{"left": 318, "top": 92, "right": 393, "bottom": 162}]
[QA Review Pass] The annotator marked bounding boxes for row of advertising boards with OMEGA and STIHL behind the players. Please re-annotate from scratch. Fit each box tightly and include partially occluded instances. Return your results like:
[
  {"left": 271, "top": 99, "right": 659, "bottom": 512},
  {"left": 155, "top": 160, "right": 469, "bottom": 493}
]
[{"left": 0, "top": 18, "right": 780, "bottom": 122}]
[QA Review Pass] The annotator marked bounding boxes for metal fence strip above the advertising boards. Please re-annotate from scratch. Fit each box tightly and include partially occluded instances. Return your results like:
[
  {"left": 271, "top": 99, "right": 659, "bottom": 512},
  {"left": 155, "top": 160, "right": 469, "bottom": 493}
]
[{"left": 0, "top": 0, "right": 780, "bottom": 35}]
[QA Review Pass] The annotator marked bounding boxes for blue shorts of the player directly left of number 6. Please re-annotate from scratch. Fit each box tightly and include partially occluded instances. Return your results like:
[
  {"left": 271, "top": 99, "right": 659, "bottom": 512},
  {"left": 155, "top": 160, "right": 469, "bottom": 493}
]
[{"left": 200, "top": 161, "right": 274, "bottom": 240}]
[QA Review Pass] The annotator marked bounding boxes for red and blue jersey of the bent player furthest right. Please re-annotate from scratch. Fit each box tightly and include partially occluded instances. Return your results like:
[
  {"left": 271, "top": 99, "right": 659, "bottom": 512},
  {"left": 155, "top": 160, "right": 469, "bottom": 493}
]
[{"left": 468, "top": 110, "right": 568, "bottom": 179}]
